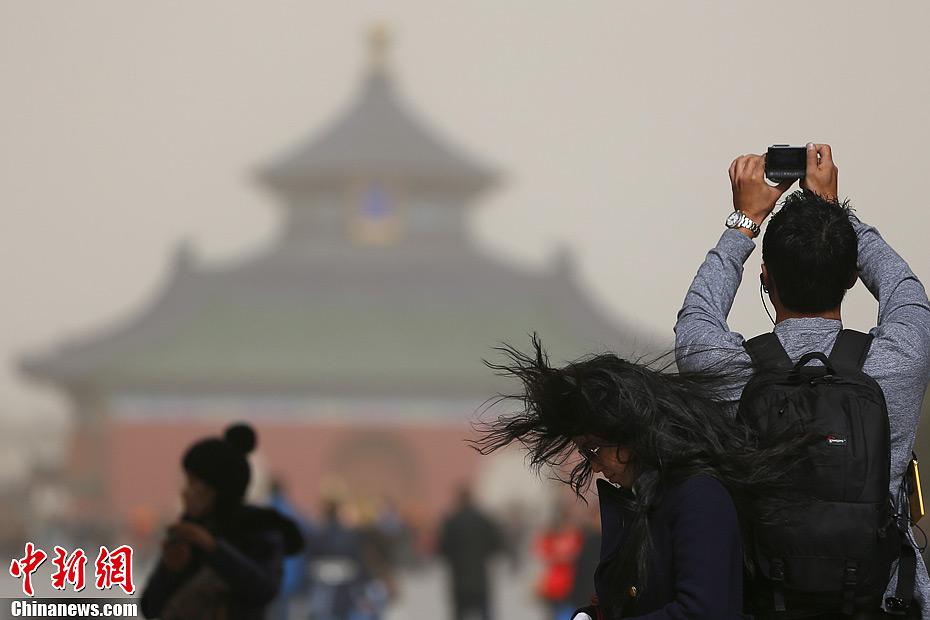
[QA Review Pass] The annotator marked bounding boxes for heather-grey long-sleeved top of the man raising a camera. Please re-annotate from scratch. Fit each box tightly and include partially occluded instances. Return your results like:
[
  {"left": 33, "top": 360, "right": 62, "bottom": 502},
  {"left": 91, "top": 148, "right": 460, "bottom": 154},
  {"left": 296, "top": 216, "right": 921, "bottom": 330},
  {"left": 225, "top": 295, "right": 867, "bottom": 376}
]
[{"left": 675, "top": 215, "right": 930, "bottom": 620}]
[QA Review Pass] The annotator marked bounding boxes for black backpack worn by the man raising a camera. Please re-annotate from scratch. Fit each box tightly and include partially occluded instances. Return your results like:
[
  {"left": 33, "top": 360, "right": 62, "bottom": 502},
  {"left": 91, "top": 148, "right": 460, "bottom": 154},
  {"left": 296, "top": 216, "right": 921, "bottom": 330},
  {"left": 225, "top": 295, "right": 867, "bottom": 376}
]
[{"left": 737, "top": 330, "right": 913, "bottom": 618}]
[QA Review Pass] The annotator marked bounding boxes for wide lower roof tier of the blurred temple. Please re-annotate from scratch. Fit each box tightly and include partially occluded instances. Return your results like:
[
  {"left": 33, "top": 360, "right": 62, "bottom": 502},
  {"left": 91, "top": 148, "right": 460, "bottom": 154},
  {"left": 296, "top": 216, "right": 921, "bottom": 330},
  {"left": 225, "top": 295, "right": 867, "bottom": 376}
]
[{"left": 23, "top": 251, "right": 643, "bottom": 396}]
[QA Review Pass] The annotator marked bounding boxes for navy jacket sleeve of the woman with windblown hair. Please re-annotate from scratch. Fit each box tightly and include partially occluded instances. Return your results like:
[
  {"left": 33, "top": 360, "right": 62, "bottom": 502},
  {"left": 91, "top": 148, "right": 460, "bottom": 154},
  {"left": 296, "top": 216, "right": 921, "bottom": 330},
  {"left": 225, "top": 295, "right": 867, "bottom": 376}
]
[{"left": 635, "top": 477, "right": 743, "bottom": 620}]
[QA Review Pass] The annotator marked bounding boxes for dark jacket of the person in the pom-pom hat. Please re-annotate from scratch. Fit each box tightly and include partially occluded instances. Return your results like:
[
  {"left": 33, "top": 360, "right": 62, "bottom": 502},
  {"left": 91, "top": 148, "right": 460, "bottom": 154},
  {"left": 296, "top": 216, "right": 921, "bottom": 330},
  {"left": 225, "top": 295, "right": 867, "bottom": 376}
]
[{"left": 141, "top": 506, "right": 304, "bottom": 620}]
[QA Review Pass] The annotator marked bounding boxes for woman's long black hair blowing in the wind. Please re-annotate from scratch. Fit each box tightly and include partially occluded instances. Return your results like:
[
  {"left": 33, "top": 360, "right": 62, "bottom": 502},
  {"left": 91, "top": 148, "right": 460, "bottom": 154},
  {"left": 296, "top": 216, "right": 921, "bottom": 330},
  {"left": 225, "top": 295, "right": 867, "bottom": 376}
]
[{"left": 473, "top": 334, "right": 808, "bottom": 615}]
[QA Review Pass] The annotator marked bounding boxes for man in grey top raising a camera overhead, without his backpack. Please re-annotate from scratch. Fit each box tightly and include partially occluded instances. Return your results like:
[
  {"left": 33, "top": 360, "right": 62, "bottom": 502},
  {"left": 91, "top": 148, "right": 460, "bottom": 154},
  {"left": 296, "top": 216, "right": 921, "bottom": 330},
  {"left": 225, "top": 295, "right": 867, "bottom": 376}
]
[{"left": 675, "top": 144, "right": 930, "bottom": 620}]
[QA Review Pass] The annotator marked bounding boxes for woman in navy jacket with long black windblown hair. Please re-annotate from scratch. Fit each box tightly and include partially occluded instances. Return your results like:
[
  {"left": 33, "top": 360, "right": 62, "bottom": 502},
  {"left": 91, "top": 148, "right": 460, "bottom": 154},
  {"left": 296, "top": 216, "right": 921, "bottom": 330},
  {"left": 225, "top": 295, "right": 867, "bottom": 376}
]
[{"left": 475, "top": 337, "right": 803, "bottom": 620}]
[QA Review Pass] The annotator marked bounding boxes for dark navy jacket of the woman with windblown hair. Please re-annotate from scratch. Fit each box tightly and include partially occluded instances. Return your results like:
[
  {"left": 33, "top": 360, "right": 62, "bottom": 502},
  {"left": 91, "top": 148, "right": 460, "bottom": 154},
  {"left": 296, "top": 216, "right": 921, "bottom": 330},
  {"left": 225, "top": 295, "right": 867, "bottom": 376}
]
[{"left": 594, "top": 475, "right": 744, "bottom": 620}]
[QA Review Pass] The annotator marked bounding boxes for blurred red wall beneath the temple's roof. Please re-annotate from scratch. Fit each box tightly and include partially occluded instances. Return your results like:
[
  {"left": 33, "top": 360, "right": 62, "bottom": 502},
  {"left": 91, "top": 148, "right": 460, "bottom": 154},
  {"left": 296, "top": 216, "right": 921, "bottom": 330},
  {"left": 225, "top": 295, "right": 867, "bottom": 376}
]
[{"left": 105, "top": 420, "right": 480, "bottom": 521}]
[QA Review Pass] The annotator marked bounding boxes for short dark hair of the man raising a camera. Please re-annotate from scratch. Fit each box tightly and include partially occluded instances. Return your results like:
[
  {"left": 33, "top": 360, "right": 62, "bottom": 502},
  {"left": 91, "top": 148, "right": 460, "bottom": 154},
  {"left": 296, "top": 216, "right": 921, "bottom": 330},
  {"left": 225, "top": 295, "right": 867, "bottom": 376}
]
[{"left": 762, "top": 190, "right": 858, "bottom": 313}]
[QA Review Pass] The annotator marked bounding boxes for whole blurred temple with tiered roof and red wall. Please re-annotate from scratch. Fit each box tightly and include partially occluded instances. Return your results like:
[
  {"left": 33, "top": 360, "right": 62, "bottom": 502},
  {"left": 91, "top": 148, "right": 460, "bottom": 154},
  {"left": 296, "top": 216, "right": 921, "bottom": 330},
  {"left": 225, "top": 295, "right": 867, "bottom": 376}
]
[{"left": 21, "top": 32, "right": 636, "bottom": 532}]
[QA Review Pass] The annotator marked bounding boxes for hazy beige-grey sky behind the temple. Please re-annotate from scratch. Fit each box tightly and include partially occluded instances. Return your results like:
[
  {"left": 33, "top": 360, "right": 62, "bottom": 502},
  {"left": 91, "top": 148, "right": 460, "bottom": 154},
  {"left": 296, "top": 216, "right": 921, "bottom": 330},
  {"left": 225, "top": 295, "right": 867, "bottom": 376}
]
[{"left": 0, "top": 0, "right": 930, "bottom": 419}]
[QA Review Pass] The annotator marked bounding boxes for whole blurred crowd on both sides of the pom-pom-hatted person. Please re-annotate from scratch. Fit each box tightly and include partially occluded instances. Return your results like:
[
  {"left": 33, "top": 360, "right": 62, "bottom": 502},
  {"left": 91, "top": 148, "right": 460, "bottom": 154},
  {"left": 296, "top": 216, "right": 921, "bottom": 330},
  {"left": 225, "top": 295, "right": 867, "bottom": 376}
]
[{"left": 3, "top": 450, "right": 600, "bottom": 620}]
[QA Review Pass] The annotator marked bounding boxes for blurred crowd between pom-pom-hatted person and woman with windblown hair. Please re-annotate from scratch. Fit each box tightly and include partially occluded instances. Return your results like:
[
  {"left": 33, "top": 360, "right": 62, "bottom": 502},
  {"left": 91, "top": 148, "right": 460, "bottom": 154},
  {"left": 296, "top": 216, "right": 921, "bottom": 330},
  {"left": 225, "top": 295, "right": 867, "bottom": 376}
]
[{"left": 252, "top": 478, "right": 600, "bottom": 620}]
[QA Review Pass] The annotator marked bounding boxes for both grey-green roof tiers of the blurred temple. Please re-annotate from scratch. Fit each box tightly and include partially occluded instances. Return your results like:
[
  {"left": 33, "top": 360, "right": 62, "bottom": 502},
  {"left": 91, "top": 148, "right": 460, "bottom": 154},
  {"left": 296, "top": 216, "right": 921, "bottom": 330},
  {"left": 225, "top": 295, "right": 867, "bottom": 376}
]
[{"left": 21, "top": 31, "right": 643, "bottom": 398}]
